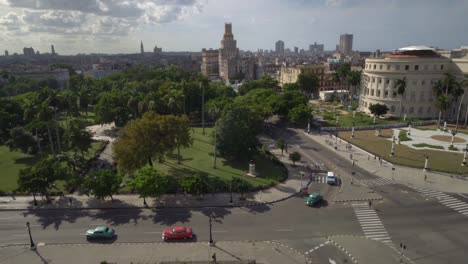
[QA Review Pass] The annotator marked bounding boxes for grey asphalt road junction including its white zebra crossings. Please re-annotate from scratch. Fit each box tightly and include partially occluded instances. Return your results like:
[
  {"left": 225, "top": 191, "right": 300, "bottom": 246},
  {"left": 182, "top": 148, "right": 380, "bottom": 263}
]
[{"left": 0, "top": 129, "right": 468, "bottom": 264}]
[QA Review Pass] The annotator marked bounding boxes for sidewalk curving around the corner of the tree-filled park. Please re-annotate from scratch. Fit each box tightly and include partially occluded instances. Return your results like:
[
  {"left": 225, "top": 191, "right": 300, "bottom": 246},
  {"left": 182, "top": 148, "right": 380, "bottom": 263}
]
[{"left": 0, "top": 137, "right": 310, "bottom": 211}]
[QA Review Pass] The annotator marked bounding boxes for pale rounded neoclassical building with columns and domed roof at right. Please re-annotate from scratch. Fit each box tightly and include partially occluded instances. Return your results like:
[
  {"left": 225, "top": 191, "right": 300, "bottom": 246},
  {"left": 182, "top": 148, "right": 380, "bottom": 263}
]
[{"left": 359, "top": 46, "right": 468, "bottom": 118}]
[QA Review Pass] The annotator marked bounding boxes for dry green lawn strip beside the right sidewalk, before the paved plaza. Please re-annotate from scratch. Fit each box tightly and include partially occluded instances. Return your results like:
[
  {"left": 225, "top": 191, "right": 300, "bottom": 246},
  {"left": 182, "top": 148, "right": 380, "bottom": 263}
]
[{"left": 338, "top": 129, "right": 468, "bottom": 174}]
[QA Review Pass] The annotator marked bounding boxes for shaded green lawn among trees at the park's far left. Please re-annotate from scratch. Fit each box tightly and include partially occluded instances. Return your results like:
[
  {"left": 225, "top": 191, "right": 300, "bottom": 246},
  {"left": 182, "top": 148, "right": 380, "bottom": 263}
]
[{"left": 0, "top": 142, "right": 101, "bottom": 192}]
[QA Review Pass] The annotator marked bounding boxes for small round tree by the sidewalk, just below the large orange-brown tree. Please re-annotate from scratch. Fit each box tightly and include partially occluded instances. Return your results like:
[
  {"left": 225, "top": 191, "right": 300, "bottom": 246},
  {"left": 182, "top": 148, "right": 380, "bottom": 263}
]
[{"left": 130, "top": 165, "right": 169, "bottom": 205}]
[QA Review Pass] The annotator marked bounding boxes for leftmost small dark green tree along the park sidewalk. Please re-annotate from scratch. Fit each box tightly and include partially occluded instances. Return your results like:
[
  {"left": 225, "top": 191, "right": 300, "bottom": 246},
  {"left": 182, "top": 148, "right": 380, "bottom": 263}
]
[{"left": 18, "top": 158, "right": 67, "bottom": 201}]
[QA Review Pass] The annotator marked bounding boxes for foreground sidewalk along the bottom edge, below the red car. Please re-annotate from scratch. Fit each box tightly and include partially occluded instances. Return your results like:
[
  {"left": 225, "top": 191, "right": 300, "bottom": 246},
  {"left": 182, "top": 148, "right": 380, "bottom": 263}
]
[{"left": 0, "top": 241, "right": 306, "bottom": 264}]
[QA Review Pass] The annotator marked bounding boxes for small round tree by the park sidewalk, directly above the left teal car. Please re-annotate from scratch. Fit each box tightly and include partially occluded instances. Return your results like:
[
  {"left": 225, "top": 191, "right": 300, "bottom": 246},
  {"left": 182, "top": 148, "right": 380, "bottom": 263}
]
[{"left": 81, "top": 170, "right": 122, "bottom": 200}]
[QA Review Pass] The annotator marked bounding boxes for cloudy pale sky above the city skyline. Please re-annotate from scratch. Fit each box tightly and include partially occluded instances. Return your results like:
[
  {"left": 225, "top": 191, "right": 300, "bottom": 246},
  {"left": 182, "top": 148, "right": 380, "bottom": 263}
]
[{"left": 0, "top": 0, "right": 468, "bottom": 55}]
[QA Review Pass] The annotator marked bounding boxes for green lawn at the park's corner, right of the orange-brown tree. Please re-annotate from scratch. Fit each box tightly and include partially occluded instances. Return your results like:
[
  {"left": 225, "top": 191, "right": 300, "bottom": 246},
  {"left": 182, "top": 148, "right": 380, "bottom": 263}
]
[{"left": 123, "top": 128, "right": 287, "bottom": 191}]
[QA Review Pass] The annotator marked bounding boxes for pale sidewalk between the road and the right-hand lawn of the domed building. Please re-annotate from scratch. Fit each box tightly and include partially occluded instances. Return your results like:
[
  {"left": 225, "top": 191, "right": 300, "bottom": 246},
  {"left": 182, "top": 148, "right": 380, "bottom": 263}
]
[{"left": 306, "top": 133, "right": 468, "bottom": 193}]
